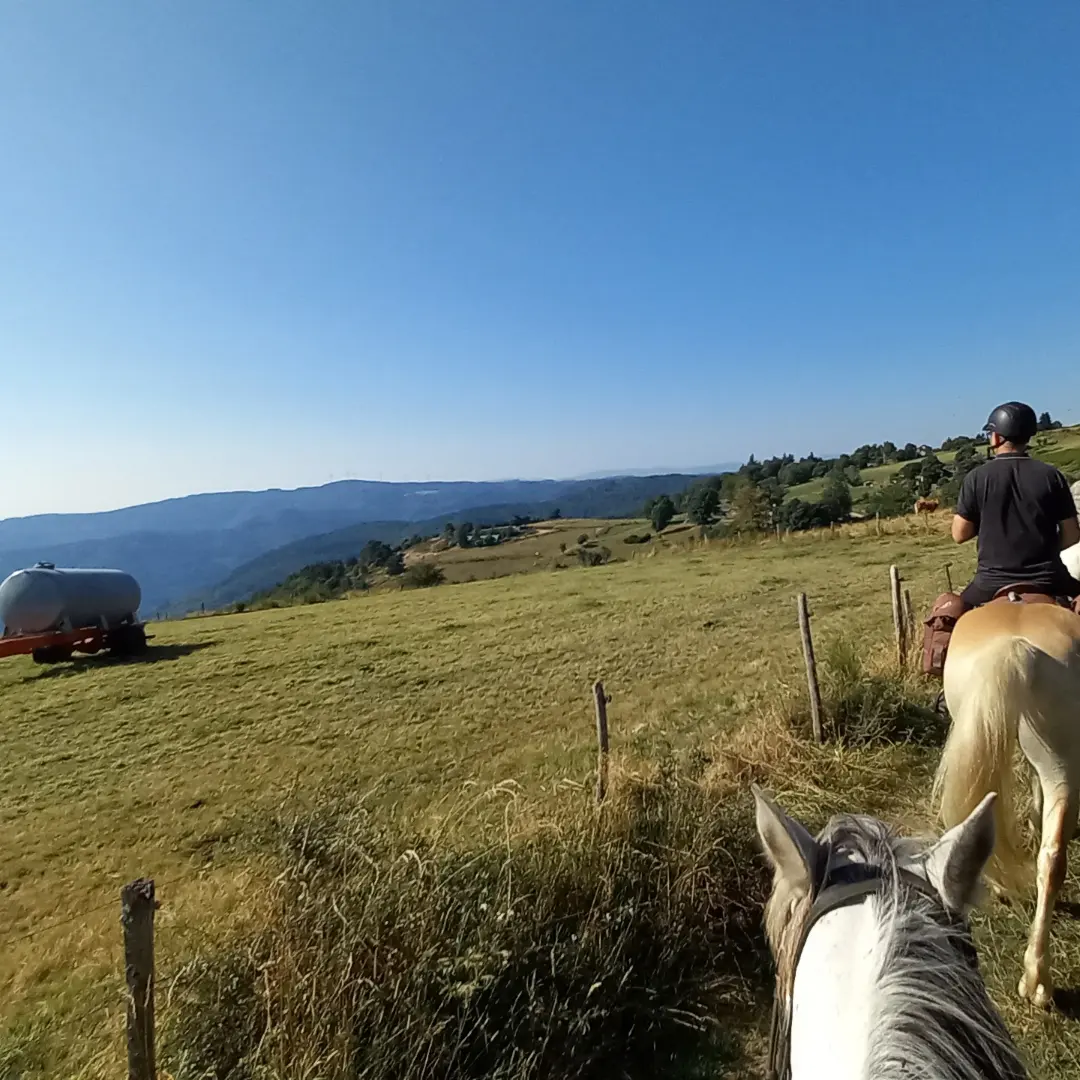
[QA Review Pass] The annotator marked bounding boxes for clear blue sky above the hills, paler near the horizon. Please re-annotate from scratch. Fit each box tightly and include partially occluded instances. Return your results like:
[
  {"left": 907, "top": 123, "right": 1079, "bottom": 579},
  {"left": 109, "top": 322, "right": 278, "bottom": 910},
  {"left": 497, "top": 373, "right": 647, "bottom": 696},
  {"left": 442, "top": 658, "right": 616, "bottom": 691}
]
[{"left": 0, "top": 0, "right": 1080, "bottom": 517}]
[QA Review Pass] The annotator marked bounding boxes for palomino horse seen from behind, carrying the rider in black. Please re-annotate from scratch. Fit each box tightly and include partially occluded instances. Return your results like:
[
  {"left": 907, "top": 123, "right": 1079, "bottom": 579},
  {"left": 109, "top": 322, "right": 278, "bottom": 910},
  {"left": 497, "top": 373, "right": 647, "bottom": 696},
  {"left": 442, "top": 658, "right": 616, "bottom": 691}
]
[{"left": 934, "top": 600, "right": 1080, "bottom": 1008}]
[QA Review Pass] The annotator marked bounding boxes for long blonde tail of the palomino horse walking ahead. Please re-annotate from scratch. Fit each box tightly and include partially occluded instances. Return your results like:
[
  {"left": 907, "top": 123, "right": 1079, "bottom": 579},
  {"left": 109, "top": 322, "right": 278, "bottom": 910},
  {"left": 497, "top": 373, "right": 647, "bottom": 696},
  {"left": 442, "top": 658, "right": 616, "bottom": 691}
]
[{"left": 933, "top": 637, "right": 1037, "bottom": 895}]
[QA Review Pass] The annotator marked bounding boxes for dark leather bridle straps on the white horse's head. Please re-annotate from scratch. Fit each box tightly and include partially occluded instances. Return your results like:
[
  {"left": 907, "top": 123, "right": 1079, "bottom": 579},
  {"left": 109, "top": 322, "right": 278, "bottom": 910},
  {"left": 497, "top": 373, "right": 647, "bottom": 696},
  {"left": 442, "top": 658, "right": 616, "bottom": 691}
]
[{"left": 766, "top": 851, "right": 978, "bottom": 1080}]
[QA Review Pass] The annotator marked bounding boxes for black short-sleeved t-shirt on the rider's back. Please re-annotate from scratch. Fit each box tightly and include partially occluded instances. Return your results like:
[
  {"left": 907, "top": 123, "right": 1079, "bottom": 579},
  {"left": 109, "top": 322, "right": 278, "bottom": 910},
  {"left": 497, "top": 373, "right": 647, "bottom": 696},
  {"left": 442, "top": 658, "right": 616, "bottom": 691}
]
[{"left": 956, "top": 454, "right": 1076, "bottom": 585}]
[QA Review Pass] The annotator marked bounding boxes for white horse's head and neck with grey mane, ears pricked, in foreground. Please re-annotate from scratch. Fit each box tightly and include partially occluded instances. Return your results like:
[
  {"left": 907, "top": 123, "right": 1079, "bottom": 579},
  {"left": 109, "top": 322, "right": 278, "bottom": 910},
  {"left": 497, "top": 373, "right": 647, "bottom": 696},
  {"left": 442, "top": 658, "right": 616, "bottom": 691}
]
[{"left": 753, "top": 786, "right": 1027, "bottom": 1080}]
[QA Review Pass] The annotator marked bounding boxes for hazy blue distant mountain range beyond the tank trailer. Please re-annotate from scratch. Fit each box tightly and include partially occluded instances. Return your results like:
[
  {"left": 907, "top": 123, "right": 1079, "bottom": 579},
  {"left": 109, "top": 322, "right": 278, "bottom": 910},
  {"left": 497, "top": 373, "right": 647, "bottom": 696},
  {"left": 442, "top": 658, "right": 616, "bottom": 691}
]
[{"left": 0, "top": 472, "right": 699, "bottom": 617}]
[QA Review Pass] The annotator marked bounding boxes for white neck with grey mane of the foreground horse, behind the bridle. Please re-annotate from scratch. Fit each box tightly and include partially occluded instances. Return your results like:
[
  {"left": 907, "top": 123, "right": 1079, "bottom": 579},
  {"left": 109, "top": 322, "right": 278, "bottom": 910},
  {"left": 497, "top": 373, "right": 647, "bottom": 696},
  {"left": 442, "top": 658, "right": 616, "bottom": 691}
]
[{"left": 791, "top": 896, "right": 1026, "bottom": 1080}]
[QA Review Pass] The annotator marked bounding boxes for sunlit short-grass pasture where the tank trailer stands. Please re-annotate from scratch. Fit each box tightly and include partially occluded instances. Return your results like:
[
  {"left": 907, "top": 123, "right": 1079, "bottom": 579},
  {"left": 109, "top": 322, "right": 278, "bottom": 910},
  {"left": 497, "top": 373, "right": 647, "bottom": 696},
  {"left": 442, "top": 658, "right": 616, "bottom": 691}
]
[{"left": 6, "top": 509, "right": 1080, "bottom": 1080}]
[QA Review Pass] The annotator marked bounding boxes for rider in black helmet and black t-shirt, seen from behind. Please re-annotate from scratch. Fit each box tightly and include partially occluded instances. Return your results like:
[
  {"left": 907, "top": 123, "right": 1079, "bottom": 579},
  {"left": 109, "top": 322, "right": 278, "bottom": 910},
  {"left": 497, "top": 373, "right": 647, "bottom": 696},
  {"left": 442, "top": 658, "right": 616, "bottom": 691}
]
[{"left": 953, "top": 402, "right": 1080, "bottom": 608}]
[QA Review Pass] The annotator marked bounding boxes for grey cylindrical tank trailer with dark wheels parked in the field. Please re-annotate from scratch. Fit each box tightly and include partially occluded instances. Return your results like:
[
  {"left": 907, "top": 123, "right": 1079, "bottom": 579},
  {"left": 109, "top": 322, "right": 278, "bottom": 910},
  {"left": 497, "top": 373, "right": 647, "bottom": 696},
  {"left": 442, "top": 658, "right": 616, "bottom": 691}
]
[{"left": 0, "top": 563, "right": 146, "bottom": 663}]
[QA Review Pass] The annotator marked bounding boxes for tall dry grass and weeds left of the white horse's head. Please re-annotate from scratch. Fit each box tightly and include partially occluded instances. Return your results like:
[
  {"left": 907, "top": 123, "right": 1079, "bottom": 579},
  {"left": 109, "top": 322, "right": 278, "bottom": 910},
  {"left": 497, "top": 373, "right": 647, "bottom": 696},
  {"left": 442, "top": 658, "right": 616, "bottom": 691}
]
[{"left": 165, "top": 769, "right": 769, "bottom": 1080}]
